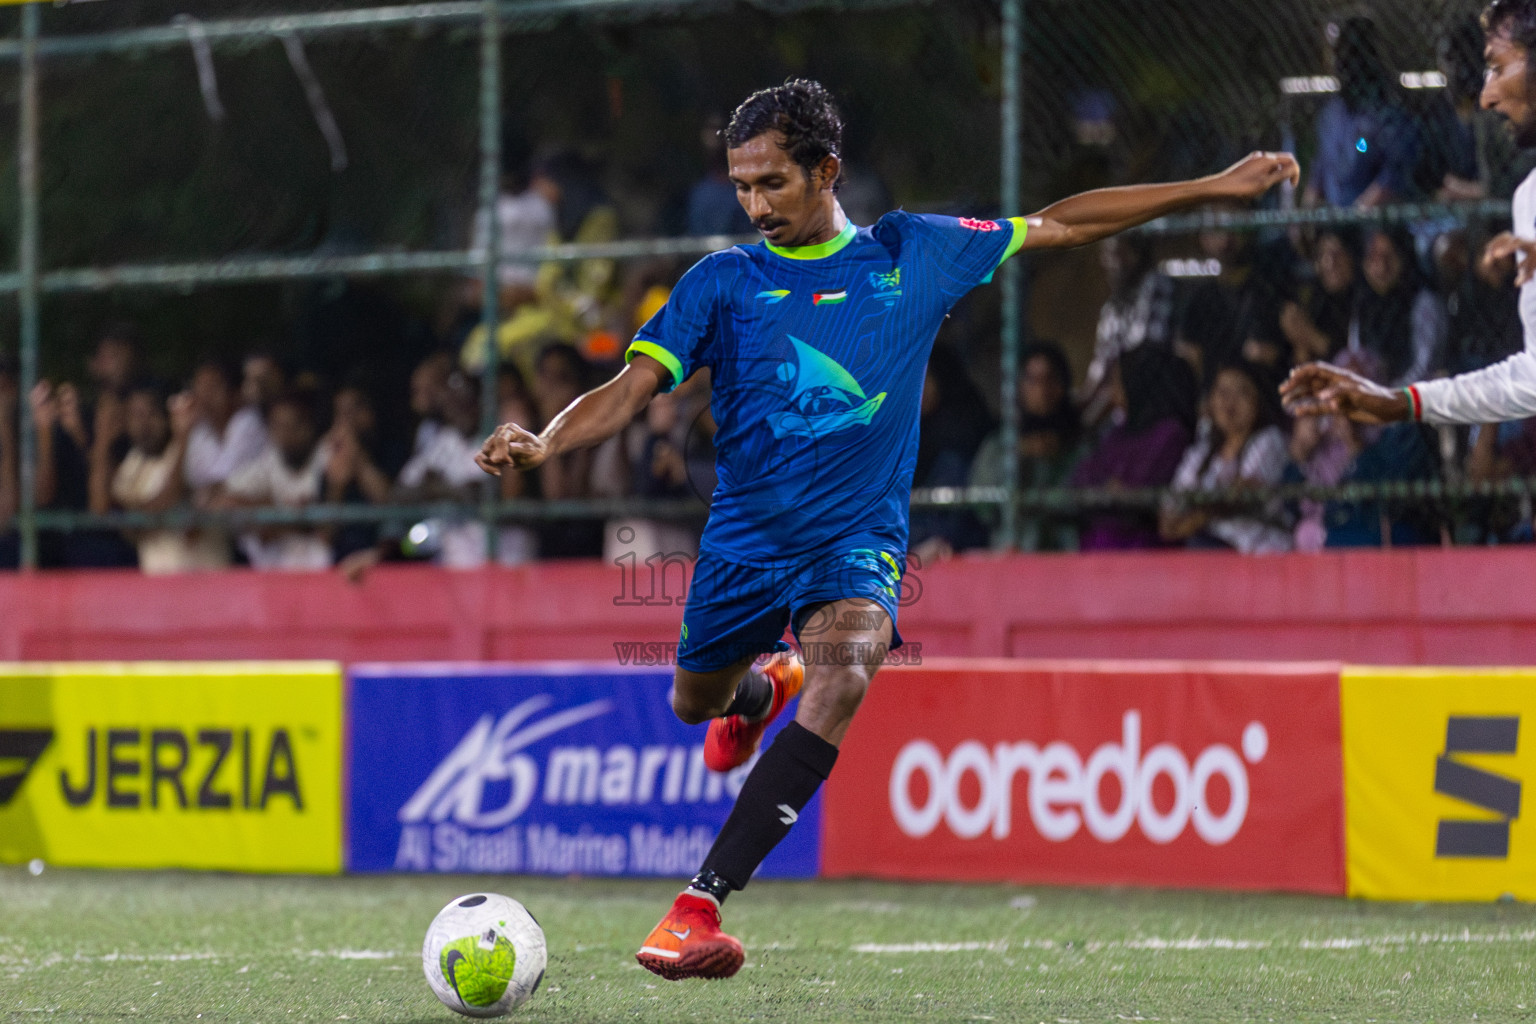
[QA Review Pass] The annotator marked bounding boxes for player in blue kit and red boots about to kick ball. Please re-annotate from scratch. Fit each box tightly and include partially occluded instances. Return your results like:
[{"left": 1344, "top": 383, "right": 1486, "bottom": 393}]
[{"left": 476, "top": 80, "right": 1299, "bottom": 979}]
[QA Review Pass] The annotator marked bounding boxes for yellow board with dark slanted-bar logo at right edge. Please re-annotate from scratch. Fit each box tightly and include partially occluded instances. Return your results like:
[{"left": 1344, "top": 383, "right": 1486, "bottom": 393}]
[{"left": 1341, "top": 668, "right": 1536, "bottom": 900}]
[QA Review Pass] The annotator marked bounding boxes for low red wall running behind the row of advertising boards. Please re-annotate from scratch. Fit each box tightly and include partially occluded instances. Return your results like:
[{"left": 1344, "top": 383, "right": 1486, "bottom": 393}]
[{"left": 0, "top": 548, "right": 1536, "bottom": 665}]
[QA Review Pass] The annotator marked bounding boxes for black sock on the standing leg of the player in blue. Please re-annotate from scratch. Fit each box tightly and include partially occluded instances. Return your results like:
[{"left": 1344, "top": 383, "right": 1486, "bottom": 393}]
[{"left": 699, "top": 722, "right": 837, "bottom": 889}]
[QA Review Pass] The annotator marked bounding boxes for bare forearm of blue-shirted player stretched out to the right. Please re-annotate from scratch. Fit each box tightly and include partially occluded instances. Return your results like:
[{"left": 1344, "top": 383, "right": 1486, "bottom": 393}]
[{"left": 1021, "top": 154, "right": 1301, "bottom": 249}]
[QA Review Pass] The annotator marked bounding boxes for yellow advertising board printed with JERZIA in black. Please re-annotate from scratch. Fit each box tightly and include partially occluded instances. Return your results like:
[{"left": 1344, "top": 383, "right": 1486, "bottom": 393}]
[{"left": 0, "top": 662, "right": 343, "bottom": 874}]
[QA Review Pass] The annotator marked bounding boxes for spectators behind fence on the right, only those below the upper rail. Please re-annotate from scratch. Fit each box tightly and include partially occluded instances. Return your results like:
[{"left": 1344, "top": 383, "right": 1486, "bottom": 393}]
[{"left": 914, "top": 216, "right": 1536, "bottom": 557}]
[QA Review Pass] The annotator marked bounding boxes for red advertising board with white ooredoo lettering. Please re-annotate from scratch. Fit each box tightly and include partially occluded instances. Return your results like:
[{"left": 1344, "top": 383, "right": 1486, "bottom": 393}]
[{"left": 822, "top": 659, "right": 1344, "bottom": 894}]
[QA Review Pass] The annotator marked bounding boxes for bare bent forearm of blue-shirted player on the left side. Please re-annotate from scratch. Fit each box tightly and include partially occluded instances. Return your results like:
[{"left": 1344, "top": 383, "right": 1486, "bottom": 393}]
[{"left": 475, "top": 353, "right": 671, "bottom": 476}]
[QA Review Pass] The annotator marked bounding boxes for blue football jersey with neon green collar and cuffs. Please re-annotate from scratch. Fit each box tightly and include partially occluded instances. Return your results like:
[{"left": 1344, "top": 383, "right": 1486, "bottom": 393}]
[{"left": 627, "top": 210, "right": 1025, "bottom": 565}]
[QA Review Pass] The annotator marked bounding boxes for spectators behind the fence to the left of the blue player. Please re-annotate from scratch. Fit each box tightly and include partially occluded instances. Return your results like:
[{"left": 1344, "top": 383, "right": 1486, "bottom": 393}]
[{"left": 0, "top": 125, "right": 737, "bottom": 573}]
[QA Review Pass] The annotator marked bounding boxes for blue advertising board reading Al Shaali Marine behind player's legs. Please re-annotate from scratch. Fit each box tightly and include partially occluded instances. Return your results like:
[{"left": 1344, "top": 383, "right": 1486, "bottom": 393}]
[{"left": 347, "top": 665, "right": 822, "bottom": 878}]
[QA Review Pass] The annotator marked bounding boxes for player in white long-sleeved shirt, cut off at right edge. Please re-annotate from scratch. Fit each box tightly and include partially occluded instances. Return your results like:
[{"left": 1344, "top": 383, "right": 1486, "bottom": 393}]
[{"left": 1279, "top": 0, "right": 1536, "bottom": 424}]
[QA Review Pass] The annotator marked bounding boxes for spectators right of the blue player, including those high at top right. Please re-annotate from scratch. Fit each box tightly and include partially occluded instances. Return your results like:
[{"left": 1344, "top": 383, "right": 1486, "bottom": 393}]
[{"left": 912, "top": 17, "right": 1536, "bottom": 557}]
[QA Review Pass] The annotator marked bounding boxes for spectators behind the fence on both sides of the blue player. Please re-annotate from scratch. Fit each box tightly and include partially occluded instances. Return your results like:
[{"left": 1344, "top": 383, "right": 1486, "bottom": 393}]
[{"left": 14, "top": 190, "right": 1536, "bottom": 573}]
